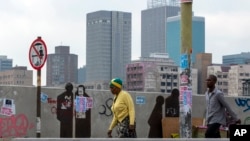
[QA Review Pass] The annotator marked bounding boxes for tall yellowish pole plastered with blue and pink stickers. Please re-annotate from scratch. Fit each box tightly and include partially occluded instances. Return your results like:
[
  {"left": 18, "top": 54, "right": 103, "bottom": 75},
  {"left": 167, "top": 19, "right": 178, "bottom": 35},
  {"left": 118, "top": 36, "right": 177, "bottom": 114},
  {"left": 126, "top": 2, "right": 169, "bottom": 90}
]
[{"left": 179, "top": 0, "right": 192, "bottom": 138}]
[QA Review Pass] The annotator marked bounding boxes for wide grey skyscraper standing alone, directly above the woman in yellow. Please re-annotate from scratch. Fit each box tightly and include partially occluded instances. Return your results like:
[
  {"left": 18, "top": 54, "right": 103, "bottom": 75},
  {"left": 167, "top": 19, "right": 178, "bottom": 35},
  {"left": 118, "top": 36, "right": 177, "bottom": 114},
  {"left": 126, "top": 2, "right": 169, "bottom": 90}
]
[{"left": 86, "top": 11, "right": 132, "bottom": 82}]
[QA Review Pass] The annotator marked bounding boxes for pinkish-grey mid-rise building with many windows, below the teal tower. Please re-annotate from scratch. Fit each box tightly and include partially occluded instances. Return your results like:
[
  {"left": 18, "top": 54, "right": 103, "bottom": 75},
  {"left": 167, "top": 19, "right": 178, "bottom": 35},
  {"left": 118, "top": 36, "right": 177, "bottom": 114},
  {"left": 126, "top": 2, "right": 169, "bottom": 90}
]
[{"left": 126, "top": 53, "right": 197, "bottom": 94}]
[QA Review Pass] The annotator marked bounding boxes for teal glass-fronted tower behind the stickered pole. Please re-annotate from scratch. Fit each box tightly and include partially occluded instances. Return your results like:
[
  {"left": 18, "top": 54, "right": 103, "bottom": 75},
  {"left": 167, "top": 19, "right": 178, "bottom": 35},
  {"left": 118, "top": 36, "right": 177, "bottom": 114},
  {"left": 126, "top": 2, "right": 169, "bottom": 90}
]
[{"left": 166, "top": 15, "right": 205, "bottom": 66}]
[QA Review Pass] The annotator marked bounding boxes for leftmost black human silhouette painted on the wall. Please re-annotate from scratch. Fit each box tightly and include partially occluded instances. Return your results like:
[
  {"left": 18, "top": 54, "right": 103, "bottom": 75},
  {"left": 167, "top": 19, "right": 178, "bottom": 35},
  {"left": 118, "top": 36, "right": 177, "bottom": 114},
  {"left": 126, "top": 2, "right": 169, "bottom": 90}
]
[{"left": 57, "top": 83, "right": 73, "bottom": 138}]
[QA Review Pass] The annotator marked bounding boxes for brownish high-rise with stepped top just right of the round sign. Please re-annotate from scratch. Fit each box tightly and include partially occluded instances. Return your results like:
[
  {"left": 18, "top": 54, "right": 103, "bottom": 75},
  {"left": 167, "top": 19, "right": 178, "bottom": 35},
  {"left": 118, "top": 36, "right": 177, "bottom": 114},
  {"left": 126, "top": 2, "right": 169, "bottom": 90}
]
[{"left": 46, "top": 46, "right": 78, "bottom": 86}]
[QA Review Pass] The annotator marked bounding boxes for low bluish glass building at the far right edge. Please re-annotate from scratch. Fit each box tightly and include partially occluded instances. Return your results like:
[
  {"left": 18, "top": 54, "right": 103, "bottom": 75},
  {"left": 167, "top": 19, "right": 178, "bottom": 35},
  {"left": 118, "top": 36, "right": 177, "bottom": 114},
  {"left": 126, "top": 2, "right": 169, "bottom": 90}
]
[{"left": 222, "top": 52, "right": 250, "bottom": 65}]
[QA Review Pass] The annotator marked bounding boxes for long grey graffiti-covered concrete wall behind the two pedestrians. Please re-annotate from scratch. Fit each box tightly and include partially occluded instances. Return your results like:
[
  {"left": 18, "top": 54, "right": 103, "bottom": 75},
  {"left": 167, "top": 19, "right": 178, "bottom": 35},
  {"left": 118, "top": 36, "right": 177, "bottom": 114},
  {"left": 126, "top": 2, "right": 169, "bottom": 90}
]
[{"left": 0, "top": 86, "right": 250, "bottom": 138}]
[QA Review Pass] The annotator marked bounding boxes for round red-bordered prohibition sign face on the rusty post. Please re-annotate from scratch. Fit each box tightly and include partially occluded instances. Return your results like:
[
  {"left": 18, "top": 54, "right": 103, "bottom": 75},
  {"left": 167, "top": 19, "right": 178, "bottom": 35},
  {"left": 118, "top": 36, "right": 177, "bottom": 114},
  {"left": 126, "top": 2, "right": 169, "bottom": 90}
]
[{"left": 29, "top": 37, "right": 47, "bottom": 70}]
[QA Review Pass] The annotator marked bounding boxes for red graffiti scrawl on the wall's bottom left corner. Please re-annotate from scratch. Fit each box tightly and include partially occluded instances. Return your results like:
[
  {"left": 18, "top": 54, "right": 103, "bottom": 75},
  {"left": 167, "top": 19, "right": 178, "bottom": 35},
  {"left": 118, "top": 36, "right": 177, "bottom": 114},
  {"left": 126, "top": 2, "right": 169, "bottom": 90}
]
[{"left": 0, "top": 114, "right": 35, "bottom": 138}]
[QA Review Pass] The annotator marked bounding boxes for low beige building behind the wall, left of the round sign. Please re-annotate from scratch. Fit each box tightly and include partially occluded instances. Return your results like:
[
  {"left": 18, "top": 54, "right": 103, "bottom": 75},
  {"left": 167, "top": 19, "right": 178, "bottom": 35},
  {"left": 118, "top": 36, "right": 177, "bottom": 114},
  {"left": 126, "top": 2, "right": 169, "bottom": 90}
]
[{"left": 0, "top": 66, "right": 33, "bottom": 86}]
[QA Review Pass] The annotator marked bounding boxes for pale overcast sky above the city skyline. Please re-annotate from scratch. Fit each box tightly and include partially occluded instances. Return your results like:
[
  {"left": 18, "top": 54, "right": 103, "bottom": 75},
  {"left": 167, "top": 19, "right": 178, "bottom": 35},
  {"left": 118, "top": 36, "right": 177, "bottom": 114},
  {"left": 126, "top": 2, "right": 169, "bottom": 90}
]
[{"left": 0, "top": 0, "right": 250, "bottom": 83}]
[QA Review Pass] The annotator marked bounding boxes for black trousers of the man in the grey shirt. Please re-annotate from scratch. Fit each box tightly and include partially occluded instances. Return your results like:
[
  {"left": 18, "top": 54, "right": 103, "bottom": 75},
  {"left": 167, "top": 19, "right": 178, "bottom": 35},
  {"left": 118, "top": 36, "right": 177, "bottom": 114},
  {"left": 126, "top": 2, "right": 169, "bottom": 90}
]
[{"left": 205, "top": 123, "right": 221, "bottom": 138}]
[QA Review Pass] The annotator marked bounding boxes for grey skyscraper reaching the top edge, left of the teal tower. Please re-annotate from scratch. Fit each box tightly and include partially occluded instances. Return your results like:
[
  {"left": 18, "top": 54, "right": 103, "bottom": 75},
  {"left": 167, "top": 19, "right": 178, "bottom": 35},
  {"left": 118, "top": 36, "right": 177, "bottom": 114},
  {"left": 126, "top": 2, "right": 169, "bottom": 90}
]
[{"left": 141, "top": 0, "right": 180, "bottom": 57}]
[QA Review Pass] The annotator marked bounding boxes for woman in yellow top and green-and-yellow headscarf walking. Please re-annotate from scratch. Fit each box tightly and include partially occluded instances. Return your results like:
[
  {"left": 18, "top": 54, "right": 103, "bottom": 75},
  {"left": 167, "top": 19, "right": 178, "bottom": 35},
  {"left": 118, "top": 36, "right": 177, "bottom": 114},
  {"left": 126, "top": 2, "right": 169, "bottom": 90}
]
[{"left": 107, "top": 78, "right": 137, "bottom": 138}]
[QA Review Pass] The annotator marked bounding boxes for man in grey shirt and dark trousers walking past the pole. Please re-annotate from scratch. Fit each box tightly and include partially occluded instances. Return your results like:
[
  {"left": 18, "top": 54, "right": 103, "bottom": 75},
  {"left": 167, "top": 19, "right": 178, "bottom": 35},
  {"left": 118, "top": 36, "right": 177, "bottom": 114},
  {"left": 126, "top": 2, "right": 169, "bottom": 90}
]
[{"left": 205, "top": 75, "right": 241, "bottom": 138}]
